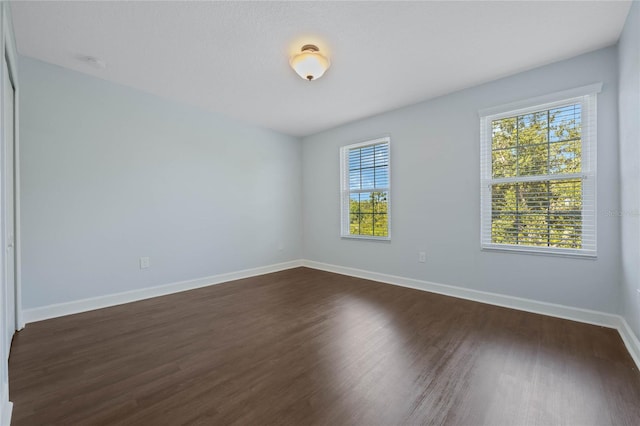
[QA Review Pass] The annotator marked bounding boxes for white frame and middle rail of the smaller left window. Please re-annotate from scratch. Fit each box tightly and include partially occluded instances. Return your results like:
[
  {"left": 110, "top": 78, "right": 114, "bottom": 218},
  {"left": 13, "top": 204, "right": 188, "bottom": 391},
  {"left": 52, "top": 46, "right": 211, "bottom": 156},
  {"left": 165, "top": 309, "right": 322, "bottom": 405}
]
[{"left": 340, "top": 136, "right": 391, "bottom": 241}]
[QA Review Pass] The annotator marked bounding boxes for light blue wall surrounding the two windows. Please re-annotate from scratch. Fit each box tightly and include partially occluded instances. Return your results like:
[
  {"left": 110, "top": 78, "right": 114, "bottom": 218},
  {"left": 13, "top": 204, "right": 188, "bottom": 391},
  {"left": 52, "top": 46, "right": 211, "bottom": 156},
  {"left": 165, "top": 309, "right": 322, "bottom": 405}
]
[{"left": 303, "top": 47, "right": 620, "bottom": 313}]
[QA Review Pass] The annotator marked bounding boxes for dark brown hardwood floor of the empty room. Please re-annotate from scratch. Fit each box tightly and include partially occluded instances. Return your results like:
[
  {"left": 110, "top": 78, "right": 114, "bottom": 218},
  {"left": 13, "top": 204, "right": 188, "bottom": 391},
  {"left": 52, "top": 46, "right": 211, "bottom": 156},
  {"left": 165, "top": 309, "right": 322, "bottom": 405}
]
[{"left": 9, "top": 268, "right": 640, "bottom": 426}]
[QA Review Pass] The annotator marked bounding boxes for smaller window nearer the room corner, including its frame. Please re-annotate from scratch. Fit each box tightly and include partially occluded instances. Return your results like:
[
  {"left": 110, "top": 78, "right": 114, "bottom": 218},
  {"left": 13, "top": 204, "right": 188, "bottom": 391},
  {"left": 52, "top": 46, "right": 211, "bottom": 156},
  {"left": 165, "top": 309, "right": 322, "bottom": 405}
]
[{"left": 340, "top": 137, "right": 391, "bottom": 240}]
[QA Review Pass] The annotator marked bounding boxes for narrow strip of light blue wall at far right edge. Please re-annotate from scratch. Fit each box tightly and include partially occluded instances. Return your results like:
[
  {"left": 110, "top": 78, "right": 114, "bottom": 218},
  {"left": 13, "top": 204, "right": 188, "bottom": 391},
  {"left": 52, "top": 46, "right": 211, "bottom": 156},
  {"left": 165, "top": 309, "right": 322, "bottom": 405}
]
[{"left": 618, "top": 1, "right": 640, "bottom": 336}]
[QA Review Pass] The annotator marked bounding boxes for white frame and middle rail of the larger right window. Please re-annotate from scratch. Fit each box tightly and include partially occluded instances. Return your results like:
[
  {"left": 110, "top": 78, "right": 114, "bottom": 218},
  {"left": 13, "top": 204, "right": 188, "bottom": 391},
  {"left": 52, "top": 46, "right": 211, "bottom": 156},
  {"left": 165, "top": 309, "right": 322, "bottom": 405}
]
[{"left": 478, "top": 83, "right": 602, "bottom": 258}]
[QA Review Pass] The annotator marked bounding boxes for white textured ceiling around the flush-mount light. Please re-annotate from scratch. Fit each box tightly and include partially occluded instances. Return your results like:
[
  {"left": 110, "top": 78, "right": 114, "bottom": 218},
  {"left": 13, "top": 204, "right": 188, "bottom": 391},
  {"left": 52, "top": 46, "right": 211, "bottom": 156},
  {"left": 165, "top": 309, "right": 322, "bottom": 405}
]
[{"left": 12, "top": 1, "right": 631, "bottom": 136}]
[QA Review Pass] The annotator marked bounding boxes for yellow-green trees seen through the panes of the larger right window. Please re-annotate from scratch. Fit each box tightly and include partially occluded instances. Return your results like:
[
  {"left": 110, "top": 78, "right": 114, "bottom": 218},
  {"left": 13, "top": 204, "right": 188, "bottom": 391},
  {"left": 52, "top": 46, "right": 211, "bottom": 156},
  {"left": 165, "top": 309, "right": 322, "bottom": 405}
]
[{"left": 491, "top": 104, "right": 582, "bottom": 249}]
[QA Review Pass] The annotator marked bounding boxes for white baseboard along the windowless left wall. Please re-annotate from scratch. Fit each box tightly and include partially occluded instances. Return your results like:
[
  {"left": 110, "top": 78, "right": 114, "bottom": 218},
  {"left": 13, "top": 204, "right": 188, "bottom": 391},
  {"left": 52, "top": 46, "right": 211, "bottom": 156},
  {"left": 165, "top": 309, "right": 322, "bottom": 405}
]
[{"left": 22, "top": 260, "right": 302, "bottom": 324}]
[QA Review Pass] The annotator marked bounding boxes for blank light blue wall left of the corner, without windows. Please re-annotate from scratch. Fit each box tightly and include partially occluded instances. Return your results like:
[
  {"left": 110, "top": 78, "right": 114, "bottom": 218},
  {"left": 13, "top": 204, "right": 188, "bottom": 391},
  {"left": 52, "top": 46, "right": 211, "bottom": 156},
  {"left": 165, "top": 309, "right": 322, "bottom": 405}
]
[{"left": 20, "top": 57, "right": 302, "bottom": 309}]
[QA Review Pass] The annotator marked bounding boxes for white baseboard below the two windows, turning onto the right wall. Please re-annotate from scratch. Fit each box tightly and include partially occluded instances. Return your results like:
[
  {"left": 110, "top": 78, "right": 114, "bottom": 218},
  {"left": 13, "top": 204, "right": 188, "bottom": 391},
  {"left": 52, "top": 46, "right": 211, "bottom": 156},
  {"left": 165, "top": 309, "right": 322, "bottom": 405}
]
[{"left": 301, "top": 259, "right": 640, "bottom": 369}]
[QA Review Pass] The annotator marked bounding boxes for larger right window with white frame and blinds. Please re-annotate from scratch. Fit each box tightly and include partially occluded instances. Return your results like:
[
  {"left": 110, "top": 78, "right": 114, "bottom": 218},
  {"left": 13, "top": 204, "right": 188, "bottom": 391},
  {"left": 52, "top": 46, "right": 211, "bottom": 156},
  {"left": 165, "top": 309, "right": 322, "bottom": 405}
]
[{"left": 480, "top": 84, "right": 601, "bottom": 257}]
